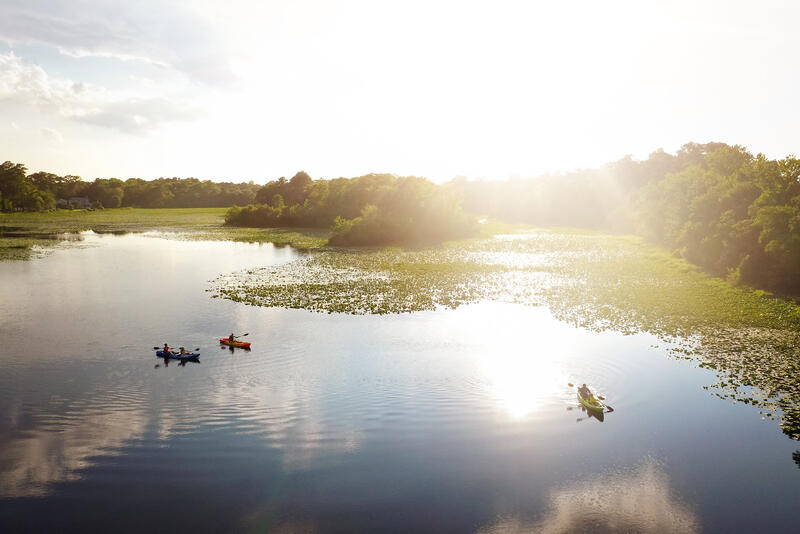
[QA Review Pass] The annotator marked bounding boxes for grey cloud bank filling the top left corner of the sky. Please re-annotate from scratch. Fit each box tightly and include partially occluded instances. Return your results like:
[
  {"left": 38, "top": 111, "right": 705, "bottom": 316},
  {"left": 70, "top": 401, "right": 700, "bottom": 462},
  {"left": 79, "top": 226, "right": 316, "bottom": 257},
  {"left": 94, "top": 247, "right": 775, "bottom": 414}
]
[{"left": 0, "top": 0, "right": 234, "bottom": 85}]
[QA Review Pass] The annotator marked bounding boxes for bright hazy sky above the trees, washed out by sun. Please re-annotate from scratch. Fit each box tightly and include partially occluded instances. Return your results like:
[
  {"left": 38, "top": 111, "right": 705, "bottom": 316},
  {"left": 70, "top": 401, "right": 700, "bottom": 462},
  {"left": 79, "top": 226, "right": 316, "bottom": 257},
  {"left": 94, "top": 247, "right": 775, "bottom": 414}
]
[{"left": 0, "top": 0, "right": 800, "bottom": 182}]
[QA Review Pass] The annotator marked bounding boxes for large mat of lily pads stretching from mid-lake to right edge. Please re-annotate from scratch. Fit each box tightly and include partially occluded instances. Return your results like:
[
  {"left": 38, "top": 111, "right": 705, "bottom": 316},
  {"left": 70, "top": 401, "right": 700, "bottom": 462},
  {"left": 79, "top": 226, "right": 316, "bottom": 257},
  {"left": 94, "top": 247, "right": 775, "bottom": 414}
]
[{"left": 211, "top": 230, "right": 800, "bottom": 439}]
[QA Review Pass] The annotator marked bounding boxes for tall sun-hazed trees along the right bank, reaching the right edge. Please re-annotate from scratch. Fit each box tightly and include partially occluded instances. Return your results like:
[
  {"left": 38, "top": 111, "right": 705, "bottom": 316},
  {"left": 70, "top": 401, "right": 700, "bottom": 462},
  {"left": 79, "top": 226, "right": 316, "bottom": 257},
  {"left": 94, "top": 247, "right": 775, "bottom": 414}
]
[{"left": 451, "top": 143, "right": 800, "bottom": 296}]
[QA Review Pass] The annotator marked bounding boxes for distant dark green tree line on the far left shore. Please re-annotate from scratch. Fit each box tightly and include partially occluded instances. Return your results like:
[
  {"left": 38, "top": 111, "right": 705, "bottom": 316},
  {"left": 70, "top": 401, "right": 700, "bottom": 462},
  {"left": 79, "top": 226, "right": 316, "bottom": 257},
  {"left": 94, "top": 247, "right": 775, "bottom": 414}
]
[{"left": 0, "top": 161, "right": 261, "bottom": 211}]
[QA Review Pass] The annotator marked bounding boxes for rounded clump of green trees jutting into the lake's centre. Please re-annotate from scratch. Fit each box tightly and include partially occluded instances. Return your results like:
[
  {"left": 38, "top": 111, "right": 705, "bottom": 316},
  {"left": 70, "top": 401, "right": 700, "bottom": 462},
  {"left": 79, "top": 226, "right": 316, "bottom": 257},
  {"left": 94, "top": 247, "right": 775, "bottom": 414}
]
[{"left": 225, "top": 171, "right": 477, "bottom": 245}]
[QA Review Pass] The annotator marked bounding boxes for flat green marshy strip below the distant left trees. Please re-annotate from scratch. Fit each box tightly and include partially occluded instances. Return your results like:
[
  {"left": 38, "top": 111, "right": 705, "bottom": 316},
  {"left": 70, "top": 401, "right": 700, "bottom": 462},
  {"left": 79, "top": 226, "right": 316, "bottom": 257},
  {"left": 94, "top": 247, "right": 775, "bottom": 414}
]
[{"left": 0, "top": 208, "right": 329, "bottom": 260}]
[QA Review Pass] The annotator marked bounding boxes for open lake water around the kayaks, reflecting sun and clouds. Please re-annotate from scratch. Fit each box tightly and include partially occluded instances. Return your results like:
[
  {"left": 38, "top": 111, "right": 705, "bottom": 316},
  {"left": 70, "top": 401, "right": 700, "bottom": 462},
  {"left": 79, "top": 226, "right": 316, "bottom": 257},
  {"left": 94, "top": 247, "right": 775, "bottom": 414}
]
[{"left": 0, "top": 234, "right": 800, "bottom": 533}]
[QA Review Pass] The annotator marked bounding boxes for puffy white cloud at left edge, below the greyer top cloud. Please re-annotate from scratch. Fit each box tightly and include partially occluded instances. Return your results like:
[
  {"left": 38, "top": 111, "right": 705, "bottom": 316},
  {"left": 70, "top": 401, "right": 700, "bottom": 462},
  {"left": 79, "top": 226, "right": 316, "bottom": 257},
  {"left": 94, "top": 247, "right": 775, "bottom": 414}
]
[{"left": 0, "top": 52, "right": 199, "bottom": 133}]
